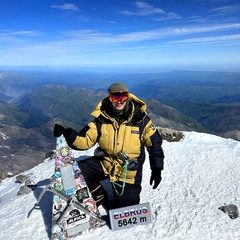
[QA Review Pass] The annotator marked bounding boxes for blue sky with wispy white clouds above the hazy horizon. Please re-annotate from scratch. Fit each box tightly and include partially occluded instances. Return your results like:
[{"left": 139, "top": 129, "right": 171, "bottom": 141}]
[{"left": 0, "top": 0, "right": 240, "bottom": 70}]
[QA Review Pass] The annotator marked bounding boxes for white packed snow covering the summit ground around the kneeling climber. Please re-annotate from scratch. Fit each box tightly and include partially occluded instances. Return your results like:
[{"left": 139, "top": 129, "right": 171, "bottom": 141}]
[{"left": 0, "top": 132, "right": 240, "bottom": 240}]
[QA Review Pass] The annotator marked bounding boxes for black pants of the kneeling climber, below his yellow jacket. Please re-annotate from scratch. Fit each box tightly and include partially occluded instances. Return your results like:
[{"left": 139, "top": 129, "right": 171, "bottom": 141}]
[{"left": 78, "top": 156, "right": 142, "bottom": 208}]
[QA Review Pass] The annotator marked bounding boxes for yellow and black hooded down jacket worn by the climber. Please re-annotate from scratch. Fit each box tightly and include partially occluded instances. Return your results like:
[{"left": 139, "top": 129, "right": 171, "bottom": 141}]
[{"left": 68, "top": 93, "right": 164, "bottom": 184}]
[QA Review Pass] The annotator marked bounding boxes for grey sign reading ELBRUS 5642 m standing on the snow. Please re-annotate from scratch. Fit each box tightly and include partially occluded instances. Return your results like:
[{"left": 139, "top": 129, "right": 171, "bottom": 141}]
[{"left": 109, "top": 203, "right": 152, "bottom": 231}]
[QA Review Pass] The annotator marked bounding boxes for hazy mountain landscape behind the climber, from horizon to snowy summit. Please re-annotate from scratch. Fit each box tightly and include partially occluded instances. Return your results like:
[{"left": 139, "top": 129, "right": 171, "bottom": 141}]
[{"left": 0, "top": 68, "right": 240, "bottom": 176}]
